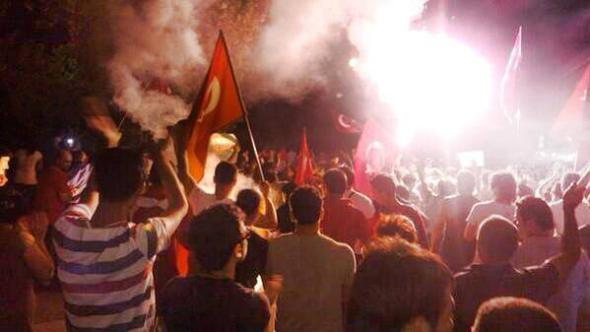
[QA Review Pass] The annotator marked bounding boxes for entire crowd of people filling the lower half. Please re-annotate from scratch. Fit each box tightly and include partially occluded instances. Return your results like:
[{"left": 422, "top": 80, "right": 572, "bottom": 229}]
[{"left": 0, "top": 129, "right": 590, "bottom": 332}]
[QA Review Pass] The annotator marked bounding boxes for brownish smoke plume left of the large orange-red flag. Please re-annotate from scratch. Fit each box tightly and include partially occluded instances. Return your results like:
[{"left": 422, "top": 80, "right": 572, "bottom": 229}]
[{"left": 108, "top": 0, "right": 205, "bottom": 138}]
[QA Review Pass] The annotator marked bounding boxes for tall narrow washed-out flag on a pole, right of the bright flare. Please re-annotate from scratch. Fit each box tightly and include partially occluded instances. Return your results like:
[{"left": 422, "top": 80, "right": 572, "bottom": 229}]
[{"left": 500, "top": 27, "right": 522, "bottom": 122}]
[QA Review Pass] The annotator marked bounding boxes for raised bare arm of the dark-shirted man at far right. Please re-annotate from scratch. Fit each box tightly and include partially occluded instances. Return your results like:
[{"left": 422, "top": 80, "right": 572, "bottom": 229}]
[{"left": 549, "top": 184, "right": 586, "bottom": 281}]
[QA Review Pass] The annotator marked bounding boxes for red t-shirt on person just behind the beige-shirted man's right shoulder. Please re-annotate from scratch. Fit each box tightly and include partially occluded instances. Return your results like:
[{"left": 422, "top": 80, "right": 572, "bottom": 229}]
[{"left": 320, "top": 197, "right": 371, "bottom": 248}]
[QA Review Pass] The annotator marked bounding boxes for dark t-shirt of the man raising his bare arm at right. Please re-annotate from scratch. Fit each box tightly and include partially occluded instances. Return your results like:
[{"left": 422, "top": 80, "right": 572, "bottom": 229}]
[{"left": 454, "top": 264, "right": 559, "bottom": 332}]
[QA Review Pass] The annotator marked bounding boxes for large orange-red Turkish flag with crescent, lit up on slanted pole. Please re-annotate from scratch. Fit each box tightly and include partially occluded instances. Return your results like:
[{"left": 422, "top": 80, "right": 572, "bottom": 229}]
[{"left": 186, "top": 32, "right": 244, "bottom": 182}]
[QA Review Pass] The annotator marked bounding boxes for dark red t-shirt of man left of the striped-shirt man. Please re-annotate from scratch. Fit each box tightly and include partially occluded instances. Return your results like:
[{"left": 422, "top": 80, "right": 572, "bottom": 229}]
[{"left": 35, "top": 166, "right": 70, "bottom": 224}]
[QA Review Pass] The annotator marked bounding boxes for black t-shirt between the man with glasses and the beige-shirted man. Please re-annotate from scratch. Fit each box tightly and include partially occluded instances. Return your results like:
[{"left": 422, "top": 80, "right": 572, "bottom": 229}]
[{"left": 236, "top": 231, "right": 268, "bottom": 288}]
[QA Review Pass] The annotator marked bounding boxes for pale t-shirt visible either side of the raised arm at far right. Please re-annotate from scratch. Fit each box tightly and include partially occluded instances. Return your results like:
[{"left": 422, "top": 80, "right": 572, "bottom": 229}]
[{"left": 512, "top": 237, "right": 590, "bottom": 332}]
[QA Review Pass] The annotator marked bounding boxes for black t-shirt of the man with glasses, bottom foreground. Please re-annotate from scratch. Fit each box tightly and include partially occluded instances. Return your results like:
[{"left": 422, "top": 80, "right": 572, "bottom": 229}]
[{"left": 158, "top": 276, "right": 270, "bottom": 332}]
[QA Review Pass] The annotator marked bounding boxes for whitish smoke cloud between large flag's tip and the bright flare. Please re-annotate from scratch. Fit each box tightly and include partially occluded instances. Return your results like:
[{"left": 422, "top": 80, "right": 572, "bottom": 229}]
[{"left": 253, "top": 0, "right": 426, "bottom": 99}]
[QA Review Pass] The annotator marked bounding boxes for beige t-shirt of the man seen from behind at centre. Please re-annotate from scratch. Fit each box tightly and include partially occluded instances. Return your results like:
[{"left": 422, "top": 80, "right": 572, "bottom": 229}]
[{"left": 267, "top": 233, "right": 356, "bottom": 332}]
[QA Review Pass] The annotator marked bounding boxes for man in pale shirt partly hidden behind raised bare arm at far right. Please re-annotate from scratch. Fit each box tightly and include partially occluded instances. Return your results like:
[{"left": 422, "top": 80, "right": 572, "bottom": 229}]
[{"left": 512, "top": 196, "right": 590, "bottom": 332}]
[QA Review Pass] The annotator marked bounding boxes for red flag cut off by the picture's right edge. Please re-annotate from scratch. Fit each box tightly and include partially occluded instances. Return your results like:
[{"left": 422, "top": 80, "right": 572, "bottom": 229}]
[{"left": 553, "top": 65, "right": 590, "bottom": 132}]
